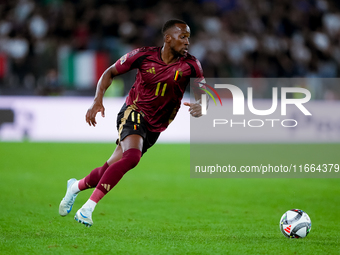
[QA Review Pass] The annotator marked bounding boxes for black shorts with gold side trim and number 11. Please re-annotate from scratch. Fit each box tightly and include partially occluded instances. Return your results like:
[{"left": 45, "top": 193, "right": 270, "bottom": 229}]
[{"left": 116, "top": 103, "right": 160, "bottom": 154}]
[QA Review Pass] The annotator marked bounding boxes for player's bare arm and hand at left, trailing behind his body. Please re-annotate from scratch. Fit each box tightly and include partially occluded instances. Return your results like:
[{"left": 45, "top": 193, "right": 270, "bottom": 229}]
[{"left": 86, "top": 65, "right": 119, "bottom": 127}]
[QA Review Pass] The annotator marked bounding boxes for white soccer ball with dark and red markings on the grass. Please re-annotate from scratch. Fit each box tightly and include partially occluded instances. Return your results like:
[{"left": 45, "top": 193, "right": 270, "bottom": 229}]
[{"left": 280, "top": 209, "right": 312, "bottom": 238}]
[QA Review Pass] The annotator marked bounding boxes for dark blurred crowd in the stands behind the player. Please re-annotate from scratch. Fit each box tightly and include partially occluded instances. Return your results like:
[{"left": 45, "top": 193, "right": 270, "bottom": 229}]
[{"left": 0, "top": 0, "right": 340, "bottom": 99}]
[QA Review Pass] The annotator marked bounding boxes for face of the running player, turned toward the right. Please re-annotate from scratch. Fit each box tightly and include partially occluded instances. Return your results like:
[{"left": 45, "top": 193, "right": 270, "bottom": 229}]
[{"left": 170, "top": 24, "right": 190, "bottom": 56}]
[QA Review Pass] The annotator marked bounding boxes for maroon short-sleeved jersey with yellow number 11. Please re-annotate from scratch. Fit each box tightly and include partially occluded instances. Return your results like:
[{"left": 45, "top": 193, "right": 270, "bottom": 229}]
[{"left": 115, "top": 47, "right": 203, "bottom": 132}]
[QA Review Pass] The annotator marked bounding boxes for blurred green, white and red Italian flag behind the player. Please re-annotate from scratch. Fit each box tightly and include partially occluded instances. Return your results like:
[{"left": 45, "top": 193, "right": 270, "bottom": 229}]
[{"left": 58, "top": 48, "right": 110, "bottom": 89}]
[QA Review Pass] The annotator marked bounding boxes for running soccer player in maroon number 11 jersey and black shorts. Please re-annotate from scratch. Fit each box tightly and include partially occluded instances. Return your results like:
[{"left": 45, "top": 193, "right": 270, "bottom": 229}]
[{"left": 59, "top": 20, "right": 204, "bottom": 227}]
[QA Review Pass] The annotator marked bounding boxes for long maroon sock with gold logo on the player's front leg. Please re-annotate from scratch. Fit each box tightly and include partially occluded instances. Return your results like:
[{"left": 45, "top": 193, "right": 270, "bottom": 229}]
[{"left": 90, "top": 149, "right": 142, "bottom": 203}]
